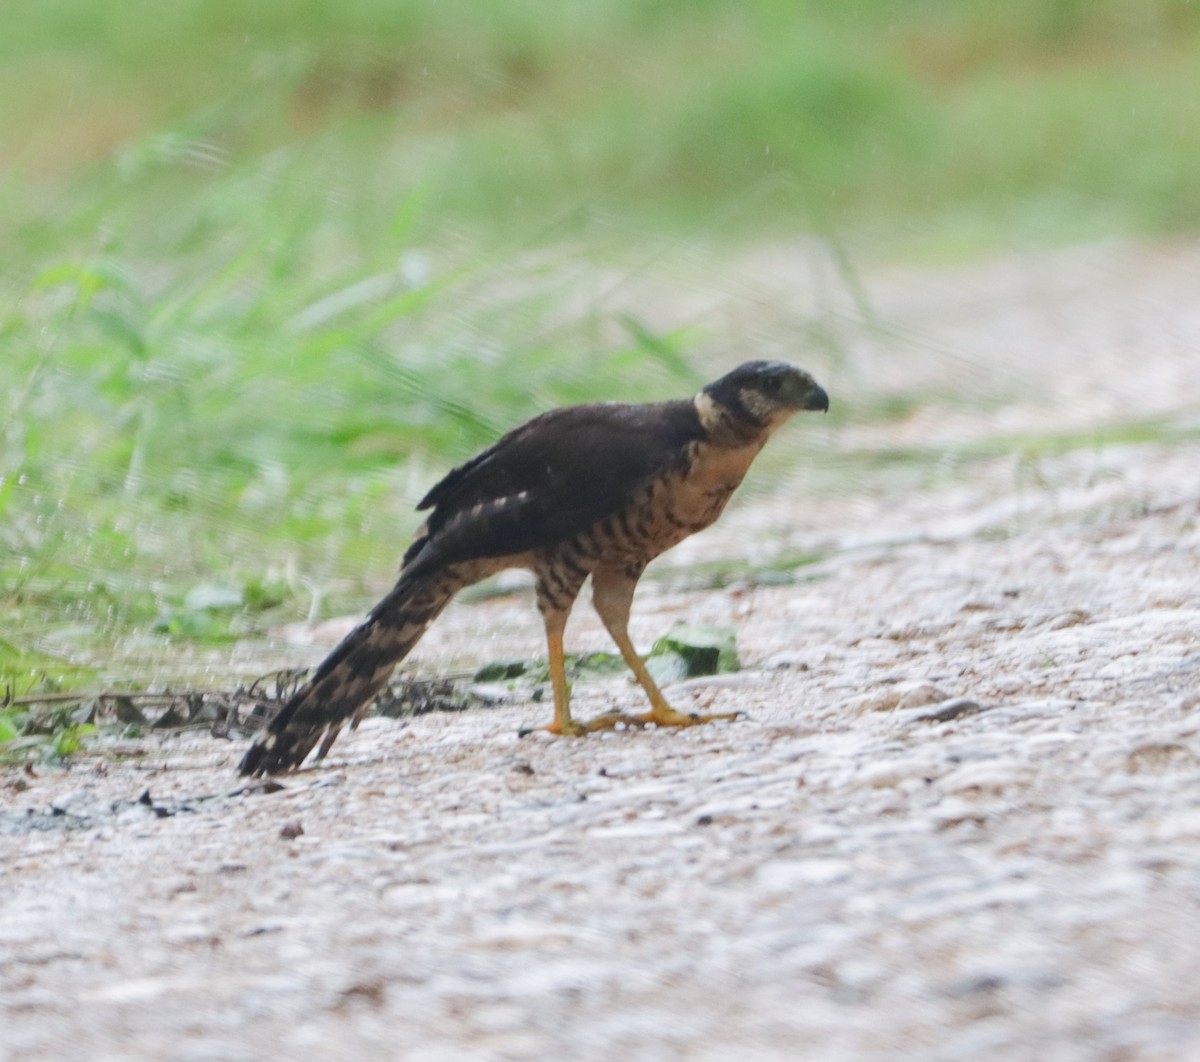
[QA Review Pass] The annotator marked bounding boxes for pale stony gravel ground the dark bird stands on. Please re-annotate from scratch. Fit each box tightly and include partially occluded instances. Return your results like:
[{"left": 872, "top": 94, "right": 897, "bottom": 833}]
[{"left": 7, "top": 236, "right": 1200, "bottom": 1060}]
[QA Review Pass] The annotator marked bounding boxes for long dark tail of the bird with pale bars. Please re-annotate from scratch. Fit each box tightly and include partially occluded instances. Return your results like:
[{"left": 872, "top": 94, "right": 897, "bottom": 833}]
[{"left": 238, "top": 568, "right": 467, "bottom": 775}]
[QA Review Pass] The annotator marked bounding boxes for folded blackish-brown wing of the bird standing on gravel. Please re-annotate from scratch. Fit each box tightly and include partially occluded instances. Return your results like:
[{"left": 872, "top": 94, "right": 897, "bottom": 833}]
[{"left": 404, "top": 401, "right": 703, "bottom": 566}]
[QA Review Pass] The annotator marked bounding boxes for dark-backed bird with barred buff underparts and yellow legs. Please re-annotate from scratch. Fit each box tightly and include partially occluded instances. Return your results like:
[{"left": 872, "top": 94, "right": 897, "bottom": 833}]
[{"left": 238, "top": 361, "right": 829, "bottom": 776}]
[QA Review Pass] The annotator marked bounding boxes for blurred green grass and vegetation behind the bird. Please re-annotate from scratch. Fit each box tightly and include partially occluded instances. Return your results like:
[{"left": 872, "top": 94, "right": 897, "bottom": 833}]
[{"left": 0, "top": 0, "right": 1200, "bottom": 720}]
